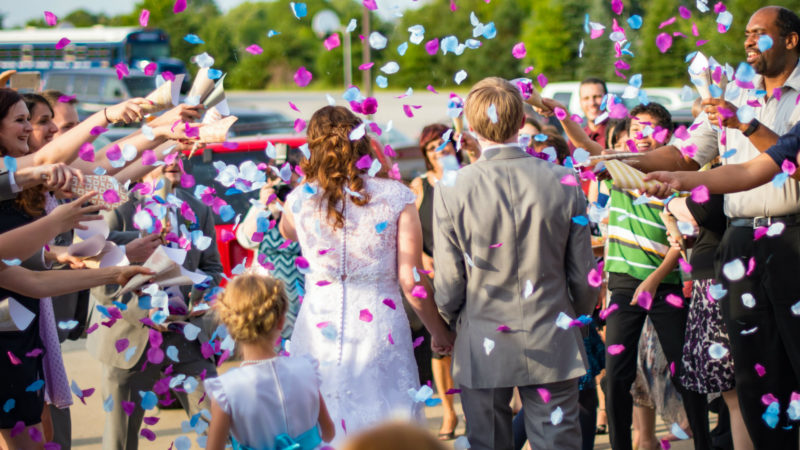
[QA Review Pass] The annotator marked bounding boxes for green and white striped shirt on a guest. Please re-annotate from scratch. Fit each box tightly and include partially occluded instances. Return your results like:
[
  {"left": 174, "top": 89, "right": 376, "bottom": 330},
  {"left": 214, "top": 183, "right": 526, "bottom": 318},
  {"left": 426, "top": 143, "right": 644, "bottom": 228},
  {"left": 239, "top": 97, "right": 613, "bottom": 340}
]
[{"left": 605, "top": 183, "right": 681, "bottom": 284}]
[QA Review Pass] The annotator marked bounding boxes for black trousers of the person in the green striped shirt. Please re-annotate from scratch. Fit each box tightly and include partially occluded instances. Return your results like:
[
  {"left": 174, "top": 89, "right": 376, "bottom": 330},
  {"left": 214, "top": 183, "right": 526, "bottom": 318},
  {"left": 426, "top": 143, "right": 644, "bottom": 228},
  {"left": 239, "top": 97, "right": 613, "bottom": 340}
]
[{"left": 606, "top": 289, "right": 711, "bottom": 450}]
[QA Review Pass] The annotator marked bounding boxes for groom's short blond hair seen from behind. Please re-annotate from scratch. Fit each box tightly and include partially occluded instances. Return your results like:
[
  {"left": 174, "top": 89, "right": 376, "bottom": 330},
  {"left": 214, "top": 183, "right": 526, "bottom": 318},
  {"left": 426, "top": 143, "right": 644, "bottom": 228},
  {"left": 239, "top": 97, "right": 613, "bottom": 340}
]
[{"left": 464, "top": 77, "right": 525, "bottom": 143}]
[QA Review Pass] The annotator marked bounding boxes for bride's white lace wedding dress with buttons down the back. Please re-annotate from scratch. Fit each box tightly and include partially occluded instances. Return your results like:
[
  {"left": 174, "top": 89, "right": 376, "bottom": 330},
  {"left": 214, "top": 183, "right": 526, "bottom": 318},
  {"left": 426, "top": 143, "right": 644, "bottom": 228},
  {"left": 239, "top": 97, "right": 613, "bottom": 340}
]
[{"left": 284, "top": 177, "right": 429, "bottom": 442}]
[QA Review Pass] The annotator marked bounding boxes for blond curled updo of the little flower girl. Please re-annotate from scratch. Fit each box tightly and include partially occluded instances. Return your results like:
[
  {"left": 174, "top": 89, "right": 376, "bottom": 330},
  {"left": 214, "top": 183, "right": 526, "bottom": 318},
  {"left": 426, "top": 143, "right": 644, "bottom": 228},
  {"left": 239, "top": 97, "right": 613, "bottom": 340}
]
[{"left": 216, "top": 273, "right": 289, "bottom": 342}]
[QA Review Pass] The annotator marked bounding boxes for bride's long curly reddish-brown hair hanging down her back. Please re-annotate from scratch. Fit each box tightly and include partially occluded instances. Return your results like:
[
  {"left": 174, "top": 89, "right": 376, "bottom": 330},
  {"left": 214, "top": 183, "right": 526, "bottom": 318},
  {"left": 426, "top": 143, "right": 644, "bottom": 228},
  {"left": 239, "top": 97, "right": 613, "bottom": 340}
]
[{"left": 300, "top": 106, "right": 386, "bottom": 228}]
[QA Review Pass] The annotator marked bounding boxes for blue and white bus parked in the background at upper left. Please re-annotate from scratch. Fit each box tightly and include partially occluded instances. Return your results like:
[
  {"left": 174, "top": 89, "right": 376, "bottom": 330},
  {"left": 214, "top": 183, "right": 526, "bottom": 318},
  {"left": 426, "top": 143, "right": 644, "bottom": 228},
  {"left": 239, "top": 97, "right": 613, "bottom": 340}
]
[{"left": 0, "top": 25, "right": 186, "bottom": 80}]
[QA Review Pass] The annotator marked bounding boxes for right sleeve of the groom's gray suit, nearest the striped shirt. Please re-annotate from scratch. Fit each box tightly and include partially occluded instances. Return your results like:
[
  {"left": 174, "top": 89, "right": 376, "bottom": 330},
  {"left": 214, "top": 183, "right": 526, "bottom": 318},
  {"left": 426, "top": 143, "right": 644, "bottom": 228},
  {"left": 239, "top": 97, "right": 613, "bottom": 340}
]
[{"left": 564, "top": 187, "right": 599, "bottom": 315}]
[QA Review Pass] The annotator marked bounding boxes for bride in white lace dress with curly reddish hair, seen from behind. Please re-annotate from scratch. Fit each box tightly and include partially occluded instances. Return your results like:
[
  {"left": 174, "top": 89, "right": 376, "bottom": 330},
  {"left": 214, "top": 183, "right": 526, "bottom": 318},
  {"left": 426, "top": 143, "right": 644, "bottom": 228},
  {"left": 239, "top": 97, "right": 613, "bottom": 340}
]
[{"left": 280, "top": 106, "right": 454, "bottom": 436}]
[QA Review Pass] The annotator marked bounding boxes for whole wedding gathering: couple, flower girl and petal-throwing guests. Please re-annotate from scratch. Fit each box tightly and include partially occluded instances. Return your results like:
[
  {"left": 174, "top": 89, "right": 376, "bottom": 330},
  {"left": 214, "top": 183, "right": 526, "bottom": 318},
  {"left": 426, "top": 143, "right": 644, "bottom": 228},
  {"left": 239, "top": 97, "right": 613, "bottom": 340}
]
[{"left": 0, "top": 6, "right": 800, "bottom": 450}]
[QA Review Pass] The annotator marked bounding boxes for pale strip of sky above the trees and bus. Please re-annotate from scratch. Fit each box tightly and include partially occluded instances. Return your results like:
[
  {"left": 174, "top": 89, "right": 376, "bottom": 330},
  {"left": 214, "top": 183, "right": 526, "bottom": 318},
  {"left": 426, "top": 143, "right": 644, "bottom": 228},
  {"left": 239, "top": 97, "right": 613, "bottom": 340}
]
[{"left": 0, "top": 0, "right": 420, "bottom": 27}]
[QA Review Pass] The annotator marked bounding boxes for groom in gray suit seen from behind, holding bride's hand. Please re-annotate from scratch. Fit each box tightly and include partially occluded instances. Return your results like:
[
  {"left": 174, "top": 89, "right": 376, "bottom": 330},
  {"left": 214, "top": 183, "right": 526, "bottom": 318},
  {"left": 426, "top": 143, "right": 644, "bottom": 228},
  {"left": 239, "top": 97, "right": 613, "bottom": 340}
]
[{"left": 433, "top": 78, "right": 597, "bottom": 450}]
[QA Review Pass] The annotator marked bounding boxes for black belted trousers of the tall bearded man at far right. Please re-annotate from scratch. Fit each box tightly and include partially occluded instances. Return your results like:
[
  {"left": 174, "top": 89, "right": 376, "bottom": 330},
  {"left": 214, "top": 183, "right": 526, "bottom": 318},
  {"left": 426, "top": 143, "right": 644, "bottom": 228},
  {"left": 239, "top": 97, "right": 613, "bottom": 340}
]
[{"left": 717, "top": 226, "right": 800, "bottom": 450}]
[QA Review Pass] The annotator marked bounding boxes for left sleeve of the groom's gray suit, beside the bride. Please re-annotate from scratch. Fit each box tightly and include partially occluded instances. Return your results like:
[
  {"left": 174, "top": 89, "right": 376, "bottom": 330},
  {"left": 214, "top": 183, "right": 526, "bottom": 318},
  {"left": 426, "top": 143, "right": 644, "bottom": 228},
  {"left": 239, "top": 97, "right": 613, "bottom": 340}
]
[{"left": 433, "top": 186, "right": 467, "bottom": 328}]
